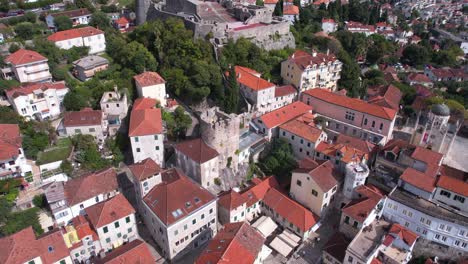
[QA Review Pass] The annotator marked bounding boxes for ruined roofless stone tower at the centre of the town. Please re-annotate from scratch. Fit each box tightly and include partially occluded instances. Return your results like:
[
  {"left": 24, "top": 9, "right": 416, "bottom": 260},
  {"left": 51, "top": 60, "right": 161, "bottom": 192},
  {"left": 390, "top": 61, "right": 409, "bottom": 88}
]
[{"left": 200, "top": 107, "right": 240, "bottom": 171}]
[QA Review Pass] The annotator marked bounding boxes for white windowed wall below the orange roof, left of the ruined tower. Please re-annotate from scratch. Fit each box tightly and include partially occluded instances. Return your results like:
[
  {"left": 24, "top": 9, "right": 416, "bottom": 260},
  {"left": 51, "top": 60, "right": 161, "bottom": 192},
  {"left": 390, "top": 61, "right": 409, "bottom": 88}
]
[{"left": 130, "top": 134, "right": 164, "bottom": 167}]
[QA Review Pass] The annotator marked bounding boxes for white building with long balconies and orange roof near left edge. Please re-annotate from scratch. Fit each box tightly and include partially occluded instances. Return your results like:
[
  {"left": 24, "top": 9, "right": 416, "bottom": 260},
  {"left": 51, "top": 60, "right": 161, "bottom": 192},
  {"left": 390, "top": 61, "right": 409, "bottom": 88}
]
[{"left": 5, "top": 49, "right": 52, "bottom": 83}]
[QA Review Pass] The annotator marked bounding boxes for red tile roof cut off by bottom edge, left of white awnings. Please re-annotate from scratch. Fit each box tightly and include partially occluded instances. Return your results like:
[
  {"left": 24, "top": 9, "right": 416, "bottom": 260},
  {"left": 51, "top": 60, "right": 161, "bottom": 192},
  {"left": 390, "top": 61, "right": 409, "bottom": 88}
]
[{"left": 195, "top": 222, "right": 265, "bottom": 264}]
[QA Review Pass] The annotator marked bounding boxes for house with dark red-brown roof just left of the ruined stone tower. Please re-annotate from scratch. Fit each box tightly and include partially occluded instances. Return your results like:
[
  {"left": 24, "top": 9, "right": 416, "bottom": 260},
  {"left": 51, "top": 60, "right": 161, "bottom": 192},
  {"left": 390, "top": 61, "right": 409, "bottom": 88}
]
[{"left": 175, "top": 138, "right": 219, "bottom": 188}]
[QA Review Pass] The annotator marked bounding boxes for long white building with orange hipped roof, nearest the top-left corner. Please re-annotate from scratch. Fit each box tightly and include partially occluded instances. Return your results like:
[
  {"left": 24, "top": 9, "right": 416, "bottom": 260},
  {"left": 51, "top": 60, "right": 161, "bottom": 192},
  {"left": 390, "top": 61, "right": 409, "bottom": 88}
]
[{"left": 47, "top": 27, "right": 106, "bottom": 54}]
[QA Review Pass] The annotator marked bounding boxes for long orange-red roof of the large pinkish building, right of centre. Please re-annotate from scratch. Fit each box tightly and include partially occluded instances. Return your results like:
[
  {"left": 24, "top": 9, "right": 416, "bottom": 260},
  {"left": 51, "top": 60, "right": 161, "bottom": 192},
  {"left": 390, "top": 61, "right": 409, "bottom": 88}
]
[{"left": 304, "top": 89, "right": 396, "bottom": 120}]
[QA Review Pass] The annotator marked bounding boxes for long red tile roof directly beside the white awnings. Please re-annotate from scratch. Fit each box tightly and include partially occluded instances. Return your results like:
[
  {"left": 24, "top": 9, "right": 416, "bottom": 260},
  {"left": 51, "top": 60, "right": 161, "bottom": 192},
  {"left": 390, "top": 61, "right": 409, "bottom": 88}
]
[{"left": 263, "top": 188, "right": 318, "bottom": 232}]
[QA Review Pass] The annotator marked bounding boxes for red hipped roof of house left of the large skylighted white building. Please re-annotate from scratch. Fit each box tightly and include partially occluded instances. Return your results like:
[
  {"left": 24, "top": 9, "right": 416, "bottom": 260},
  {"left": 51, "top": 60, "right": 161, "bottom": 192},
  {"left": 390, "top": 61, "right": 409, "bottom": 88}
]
[{"left": 85, "top": 193, "right": 135, "bottom": 229}]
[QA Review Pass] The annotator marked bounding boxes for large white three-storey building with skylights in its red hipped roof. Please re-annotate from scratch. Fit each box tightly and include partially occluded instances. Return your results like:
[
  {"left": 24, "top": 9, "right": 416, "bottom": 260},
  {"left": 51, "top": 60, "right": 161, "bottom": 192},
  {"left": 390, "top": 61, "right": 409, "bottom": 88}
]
[{"left": 143, "top": 168, "right": 217, "bottom": 260}]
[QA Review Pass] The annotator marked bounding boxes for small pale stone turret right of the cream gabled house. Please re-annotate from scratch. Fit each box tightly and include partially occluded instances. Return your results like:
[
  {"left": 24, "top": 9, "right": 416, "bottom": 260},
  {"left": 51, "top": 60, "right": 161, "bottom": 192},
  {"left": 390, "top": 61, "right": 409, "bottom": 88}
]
[{"left": 343, "top": 162, "right": 369, "bottom": 199}]
